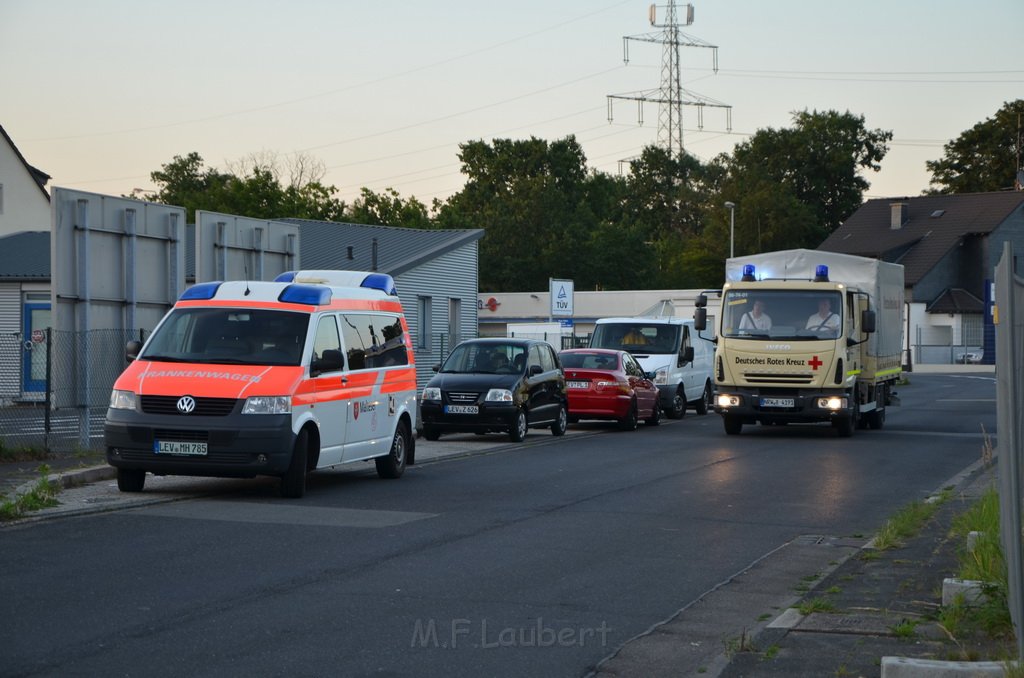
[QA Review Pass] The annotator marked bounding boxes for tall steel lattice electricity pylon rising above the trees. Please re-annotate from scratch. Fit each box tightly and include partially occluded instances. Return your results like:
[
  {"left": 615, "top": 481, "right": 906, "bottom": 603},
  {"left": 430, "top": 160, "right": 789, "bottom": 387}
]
[{"left": 607, "top": 0, "right": 732, "bottom": 158}]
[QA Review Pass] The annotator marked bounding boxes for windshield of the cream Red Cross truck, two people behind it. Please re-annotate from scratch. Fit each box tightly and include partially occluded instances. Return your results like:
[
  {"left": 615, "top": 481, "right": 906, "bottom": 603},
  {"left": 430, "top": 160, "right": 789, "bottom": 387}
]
[{"left": 722, "top": 289, "right": 844, "bottom": 341}]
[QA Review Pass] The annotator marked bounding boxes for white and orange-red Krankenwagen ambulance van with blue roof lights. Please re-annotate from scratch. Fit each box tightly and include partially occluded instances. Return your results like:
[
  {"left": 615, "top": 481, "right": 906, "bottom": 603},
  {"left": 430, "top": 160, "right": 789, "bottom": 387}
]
[{"left": 103, "top": 270, "right": 417, "bottom": 497}]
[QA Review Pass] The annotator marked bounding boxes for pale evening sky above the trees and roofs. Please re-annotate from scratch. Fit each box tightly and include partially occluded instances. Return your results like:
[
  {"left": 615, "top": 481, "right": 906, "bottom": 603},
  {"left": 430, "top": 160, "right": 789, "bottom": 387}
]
[{"left": 0, "top": 0, "right": 1024, "bottom": 206}]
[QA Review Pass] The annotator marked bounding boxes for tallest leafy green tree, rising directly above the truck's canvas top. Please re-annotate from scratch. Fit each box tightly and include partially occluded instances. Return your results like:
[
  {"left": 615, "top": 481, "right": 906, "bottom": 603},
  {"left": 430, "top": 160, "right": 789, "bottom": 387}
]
[{"left": 725, "top": 111, "right": 892, "bottom": 236}]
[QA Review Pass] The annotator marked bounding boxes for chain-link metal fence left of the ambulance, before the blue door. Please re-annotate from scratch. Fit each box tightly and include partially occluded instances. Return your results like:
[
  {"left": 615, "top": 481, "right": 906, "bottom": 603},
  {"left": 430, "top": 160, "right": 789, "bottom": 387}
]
[{"left": 0, "top": 330, "right": 142, "bottom": 453}]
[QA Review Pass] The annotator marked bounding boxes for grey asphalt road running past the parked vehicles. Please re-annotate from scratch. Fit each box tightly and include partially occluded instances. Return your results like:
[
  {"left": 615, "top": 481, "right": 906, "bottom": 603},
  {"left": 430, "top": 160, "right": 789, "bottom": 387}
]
[{"left": 0, "top": 375, "right": 995, "bottom": 676}]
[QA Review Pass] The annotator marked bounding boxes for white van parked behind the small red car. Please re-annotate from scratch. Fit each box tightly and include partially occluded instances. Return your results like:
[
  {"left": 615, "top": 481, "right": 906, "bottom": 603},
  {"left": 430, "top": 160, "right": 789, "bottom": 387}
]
[{"left": 590, "top": 316, "right": 714, "bottom": 419}]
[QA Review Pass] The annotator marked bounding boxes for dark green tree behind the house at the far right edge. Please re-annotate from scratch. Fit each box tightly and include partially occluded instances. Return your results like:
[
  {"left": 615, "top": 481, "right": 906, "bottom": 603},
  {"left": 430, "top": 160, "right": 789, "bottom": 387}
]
[{"left": 925, "top": 99, "right": 1024, "bottom": 195}]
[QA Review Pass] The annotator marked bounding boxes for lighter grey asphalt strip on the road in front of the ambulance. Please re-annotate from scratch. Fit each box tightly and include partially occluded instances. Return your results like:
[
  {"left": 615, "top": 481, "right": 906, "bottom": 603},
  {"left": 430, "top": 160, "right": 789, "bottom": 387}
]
[{"left": 129, "top": 500, "right": 438, "bottom": 528}]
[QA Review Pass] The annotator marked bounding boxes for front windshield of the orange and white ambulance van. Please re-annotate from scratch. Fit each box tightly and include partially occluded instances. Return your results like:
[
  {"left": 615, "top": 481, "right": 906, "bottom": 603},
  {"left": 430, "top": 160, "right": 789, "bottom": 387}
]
[{"left": 139, "top": 308, "right": 309, "bottom": 366}]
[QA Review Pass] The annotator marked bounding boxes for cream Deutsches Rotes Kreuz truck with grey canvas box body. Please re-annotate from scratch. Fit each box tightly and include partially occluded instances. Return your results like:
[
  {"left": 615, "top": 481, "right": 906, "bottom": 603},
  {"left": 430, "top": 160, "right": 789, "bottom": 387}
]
[{"left": 695, "top": 250, "right": 904, "bottom": 436}]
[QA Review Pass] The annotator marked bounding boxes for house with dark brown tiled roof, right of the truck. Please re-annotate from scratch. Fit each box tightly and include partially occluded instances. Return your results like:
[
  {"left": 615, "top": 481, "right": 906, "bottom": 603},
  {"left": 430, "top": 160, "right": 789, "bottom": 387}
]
[{"left": 818, "top": 190, "right": 1024, "bottom": 363}]
